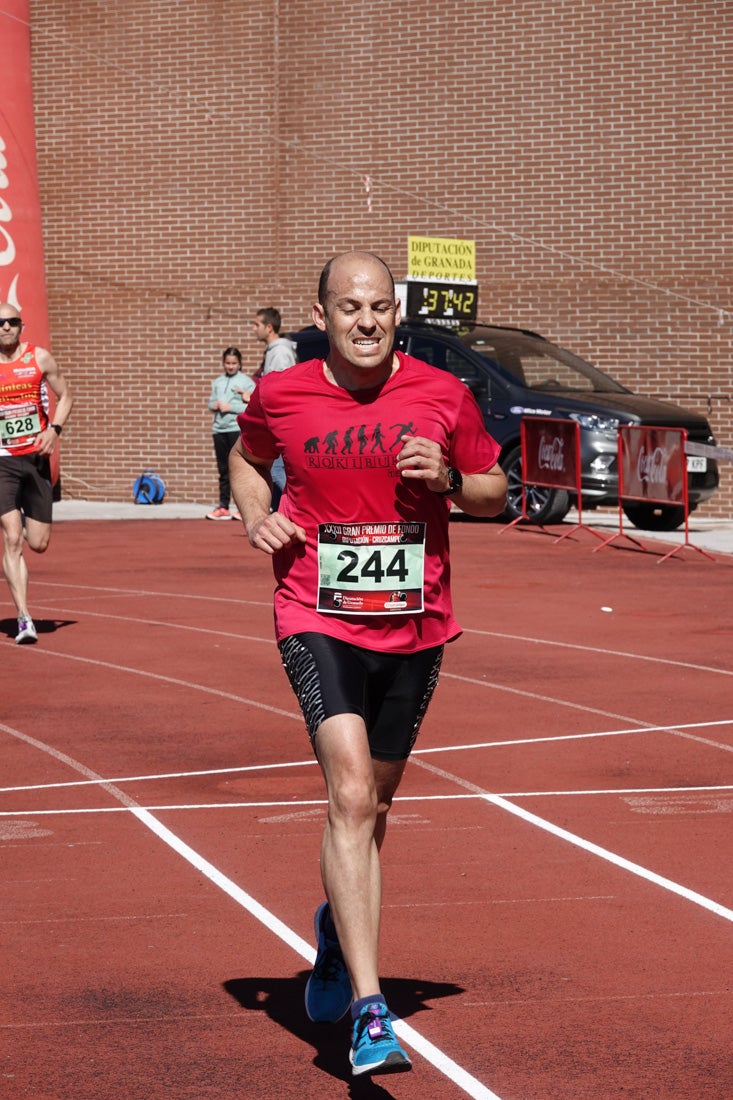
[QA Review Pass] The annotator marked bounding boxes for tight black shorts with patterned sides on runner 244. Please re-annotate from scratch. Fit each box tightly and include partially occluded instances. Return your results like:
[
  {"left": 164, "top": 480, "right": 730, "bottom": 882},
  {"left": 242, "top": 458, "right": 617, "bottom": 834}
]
[{"left": 278, "top": 631, "right": 444, "bottom": 760}]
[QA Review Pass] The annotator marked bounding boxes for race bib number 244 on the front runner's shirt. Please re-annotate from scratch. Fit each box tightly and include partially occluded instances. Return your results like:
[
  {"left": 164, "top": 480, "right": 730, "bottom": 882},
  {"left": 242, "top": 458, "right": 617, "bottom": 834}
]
[{"left": 317, "top": 523, "right": 425, "bottom": 615}]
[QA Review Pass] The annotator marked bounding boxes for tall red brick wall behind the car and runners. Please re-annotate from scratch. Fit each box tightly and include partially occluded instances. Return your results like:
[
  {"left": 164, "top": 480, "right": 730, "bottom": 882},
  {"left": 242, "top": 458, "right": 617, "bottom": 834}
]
[{"left": 24, "top": 0, "right": 733, "bottom": 516}]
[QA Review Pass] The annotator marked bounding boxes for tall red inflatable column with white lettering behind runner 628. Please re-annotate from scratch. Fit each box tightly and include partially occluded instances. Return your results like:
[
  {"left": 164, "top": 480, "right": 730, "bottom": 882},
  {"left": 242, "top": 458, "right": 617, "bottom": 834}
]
[{"left": 0, "top": 0, "right": 58, "bottom": 482}]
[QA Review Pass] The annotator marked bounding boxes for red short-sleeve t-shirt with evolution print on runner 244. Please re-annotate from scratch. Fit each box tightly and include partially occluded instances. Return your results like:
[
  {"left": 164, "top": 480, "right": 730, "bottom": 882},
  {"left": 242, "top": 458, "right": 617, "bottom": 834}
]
[{"left": 238, "top": 352, "right": 500, "bottom": 653}]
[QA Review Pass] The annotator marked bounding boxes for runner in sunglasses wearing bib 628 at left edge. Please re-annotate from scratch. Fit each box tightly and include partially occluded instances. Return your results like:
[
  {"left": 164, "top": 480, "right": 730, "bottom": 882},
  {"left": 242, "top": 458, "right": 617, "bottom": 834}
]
[{"left": 0, "top": 301, "right": 73, "bottom": 645}]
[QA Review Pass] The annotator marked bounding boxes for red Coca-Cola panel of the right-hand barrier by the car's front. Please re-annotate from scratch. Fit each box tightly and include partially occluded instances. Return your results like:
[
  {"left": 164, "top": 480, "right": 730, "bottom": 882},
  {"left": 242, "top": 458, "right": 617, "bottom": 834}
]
[{"left": 619, "top": 425, "right": 687, "bottom": 505}]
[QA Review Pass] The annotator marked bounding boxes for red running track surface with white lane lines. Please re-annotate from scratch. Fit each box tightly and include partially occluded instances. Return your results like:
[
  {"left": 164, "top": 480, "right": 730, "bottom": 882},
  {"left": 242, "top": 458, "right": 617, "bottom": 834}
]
[{"left": 0, "top": 520, "right": 733, "bottom": 1100}]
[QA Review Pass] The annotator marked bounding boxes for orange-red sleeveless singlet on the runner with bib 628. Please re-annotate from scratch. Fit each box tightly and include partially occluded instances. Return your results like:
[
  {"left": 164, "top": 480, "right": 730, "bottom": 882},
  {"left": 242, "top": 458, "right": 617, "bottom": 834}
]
[{"left": 0, "top": 344, "right": 48, "bottom": 457}]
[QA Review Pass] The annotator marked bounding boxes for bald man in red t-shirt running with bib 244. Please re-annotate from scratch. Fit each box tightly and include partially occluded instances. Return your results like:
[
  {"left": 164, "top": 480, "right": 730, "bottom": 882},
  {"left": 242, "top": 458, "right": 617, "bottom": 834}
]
[{"left": 230, "top": 252, "right": 506, "bottom": 1076}]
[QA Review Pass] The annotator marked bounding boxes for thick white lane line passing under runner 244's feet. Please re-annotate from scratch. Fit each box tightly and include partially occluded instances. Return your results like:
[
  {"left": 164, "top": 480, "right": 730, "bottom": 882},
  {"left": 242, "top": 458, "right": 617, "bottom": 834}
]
[{"left": 2, "top": 726, "right": 501, "bottom": 1100}]
